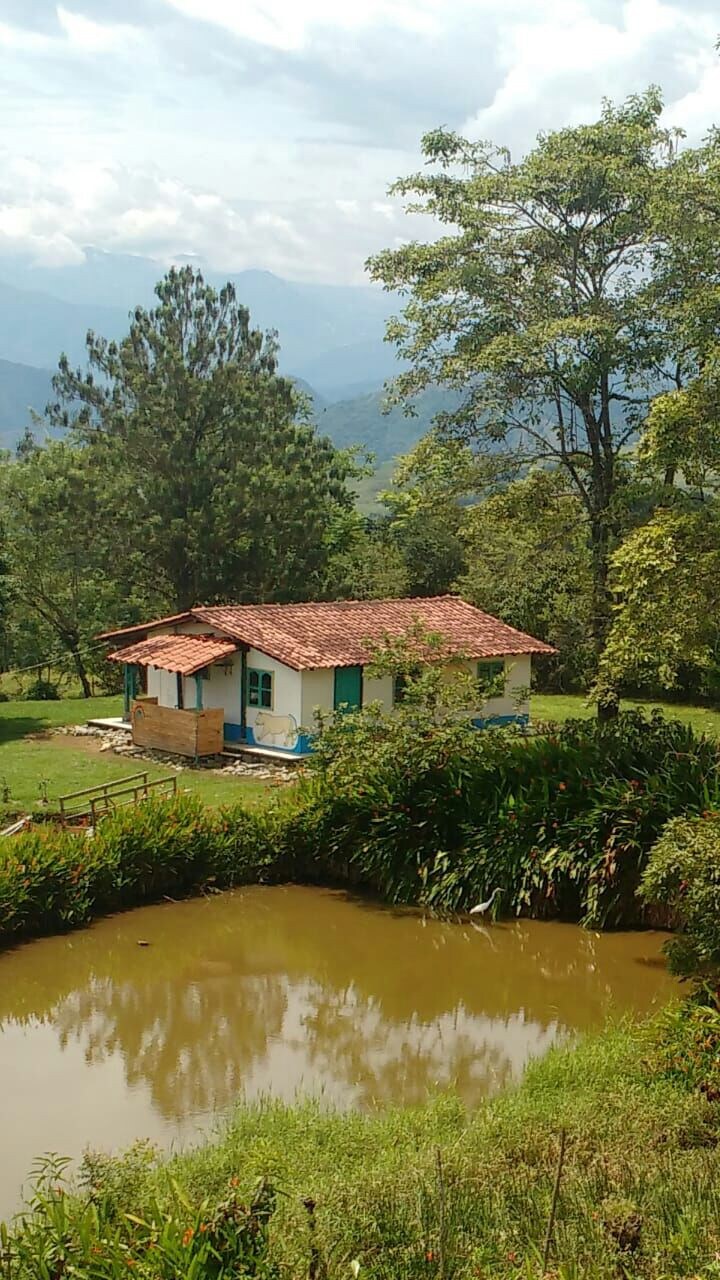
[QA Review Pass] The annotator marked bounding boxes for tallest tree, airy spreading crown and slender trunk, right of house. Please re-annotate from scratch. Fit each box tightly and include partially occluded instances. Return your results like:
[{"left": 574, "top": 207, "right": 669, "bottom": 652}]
[{"left": 369, "top": 90, "right": 676, "bottom": 714}]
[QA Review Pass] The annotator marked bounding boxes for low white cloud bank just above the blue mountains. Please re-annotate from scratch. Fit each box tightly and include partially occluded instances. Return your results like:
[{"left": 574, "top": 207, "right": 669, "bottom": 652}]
[{"left": 0, "top": 154, "right": 425, "bottom": 282}]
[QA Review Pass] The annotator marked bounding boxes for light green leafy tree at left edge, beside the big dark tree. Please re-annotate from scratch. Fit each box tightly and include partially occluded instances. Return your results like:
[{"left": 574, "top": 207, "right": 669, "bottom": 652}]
[{"left": 0, "top": 442, "right": 148, "bottom": 698}]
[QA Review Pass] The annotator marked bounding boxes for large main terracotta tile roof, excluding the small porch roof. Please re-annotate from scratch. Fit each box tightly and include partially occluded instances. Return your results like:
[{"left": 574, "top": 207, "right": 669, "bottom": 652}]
[{"left": 192, "top": 595, "right": 555, "bottom": 671}]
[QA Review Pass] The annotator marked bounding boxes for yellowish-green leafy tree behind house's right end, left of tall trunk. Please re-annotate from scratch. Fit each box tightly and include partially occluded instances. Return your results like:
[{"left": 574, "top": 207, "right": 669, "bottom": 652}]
[{"left": 459, "top": 470, "right": 593, "bottom": 687}]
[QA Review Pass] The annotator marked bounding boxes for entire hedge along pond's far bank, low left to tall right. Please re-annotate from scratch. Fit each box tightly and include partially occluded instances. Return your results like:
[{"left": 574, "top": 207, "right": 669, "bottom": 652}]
[{"left": 0, "top": 709, "right": 720, "bottom": 945}]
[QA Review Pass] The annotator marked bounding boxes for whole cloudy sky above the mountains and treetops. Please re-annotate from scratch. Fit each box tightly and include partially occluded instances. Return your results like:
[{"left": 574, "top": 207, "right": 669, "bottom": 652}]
[{"left": 0, "top": 0, "right": 720, "bottom": 283}]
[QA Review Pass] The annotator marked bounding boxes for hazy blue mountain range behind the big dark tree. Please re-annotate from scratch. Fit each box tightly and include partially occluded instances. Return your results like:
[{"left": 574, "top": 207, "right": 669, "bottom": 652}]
[{"left": 0, "top": 250, "right": 442, "bottom": 462}]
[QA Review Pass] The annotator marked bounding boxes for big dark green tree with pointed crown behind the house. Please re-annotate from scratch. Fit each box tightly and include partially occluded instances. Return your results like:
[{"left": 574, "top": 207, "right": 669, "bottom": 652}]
[{"left": 49, "top": 268, "right": 352, "bottom": 608}]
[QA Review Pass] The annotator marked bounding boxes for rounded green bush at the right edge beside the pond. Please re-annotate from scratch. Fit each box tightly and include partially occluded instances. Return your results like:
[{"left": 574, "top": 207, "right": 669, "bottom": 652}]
[{"left": 641, "top": 814, "right": 720, "bottom": 986}]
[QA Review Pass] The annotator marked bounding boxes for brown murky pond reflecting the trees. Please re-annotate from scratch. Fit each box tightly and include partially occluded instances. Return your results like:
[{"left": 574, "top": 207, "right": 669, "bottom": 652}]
[{"left": 0, "top": 887, "right": 676, "bottom": 1216}]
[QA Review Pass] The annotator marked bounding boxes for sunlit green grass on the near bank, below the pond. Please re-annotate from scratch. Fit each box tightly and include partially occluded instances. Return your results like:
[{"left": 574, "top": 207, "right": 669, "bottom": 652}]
[{"left": 13, "top": 1028, "right": 720, "bottom": 1280}]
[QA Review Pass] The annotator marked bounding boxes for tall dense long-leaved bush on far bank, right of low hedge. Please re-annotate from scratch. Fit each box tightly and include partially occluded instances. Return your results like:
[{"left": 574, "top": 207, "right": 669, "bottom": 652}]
[{"left": 302, "top": 708, "right": 720, "bottom": 925}]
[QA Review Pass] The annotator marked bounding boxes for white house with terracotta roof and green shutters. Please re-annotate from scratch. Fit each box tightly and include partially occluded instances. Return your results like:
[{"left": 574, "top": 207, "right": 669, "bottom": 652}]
[{"left": 101, "top": 595, "right": 553, "bottom": 755}]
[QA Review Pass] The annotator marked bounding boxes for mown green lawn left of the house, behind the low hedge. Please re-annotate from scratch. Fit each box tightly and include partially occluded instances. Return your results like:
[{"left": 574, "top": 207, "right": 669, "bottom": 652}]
[{"left": 0, "top": 698, "right": 279, "bottom": 814}]
